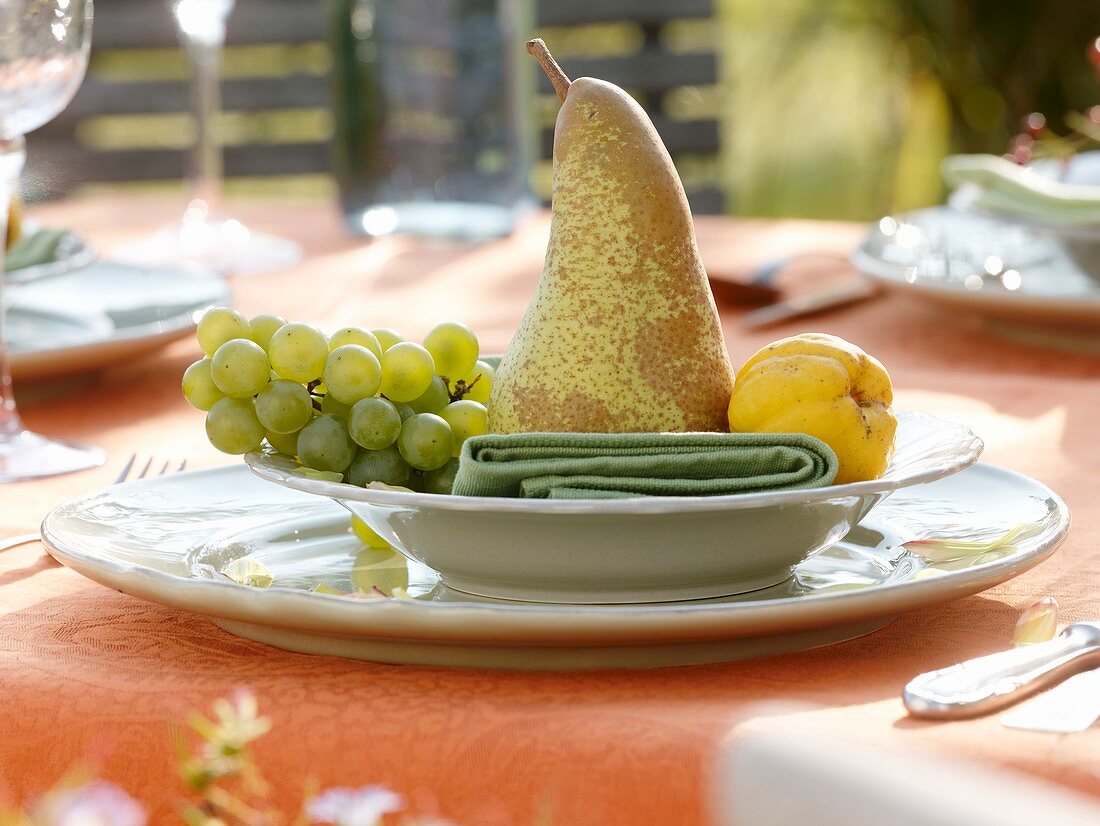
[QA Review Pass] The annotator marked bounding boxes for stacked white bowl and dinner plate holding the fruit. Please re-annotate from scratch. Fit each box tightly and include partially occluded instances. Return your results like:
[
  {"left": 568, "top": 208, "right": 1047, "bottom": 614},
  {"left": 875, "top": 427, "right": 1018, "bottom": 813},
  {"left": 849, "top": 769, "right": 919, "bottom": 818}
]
[{"left": 43, "top": 414, "right": 1069, "bottom": 669}]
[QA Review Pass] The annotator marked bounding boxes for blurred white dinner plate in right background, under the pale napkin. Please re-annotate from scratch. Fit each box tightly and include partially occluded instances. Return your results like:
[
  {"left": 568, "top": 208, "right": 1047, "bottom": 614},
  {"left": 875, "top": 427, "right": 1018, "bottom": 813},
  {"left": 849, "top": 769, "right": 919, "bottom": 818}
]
[{"left": 851, "top": 207, "right": 1100, "bottom": 349}]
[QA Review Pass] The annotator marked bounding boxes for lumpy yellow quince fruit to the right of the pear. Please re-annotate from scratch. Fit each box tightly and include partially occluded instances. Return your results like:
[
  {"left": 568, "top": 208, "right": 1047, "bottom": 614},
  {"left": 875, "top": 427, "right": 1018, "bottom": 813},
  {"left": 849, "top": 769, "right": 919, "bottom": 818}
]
[{"left": 729, "top": 333, "right": 898, "bottom": 485}]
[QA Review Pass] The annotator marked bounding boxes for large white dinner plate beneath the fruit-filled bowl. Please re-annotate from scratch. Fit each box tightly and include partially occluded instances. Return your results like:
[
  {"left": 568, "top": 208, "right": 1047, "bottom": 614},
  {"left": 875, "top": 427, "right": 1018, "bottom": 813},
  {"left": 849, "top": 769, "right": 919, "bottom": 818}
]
[{"left": 42, "top": 464, "right": 1069, "bottom": 669}]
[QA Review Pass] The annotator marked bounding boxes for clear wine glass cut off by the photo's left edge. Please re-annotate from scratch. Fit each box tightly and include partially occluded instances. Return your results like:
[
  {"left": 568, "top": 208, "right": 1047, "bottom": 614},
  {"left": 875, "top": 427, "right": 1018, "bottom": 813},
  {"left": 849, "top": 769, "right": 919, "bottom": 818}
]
[{"left": 0, "top": 0, "right": 103, "bottom": 482}]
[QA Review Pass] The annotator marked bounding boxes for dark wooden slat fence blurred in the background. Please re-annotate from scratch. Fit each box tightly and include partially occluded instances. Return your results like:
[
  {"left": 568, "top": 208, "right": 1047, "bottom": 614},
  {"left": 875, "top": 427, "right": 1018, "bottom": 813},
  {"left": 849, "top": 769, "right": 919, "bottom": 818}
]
[{"left": 24, "top": 0, "right": 724, "bottom": 212}]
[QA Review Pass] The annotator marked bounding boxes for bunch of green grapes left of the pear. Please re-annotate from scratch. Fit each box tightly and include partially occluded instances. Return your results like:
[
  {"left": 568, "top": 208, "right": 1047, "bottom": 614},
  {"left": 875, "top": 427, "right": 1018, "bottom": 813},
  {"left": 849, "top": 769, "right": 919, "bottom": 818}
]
[{"left": 183, "top": 307, "right": 493, "bottom": 493}]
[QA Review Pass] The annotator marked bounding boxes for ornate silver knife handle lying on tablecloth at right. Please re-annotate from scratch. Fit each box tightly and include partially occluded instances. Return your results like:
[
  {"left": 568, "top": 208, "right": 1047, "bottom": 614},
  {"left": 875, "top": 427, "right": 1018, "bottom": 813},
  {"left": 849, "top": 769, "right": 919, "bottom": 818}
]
[{"left": 902, "top": 623, "right": 1100, "bottom": 719}]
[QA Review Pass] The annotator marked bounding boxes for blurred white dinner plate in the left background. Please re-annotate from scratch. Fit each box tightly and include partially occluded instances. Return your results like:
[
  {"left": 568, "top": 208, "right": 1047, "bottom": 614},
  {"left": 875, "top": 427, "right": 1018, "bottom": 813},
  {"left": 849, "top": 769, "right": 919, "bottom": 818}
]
[{"left": 6, "top": 261, "right": 230, "bottom": 381}]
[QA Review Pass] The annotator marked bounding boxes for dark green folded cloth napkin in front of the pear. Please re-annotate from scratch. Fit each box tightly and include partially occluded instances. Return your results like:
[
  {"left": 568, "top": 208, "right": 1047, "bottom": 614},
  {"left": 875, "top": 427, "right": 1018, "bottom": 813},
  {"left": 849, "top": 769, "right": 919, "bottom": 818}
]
[{"left": 452, "top": 433, "right": 837, "bottom": 499}]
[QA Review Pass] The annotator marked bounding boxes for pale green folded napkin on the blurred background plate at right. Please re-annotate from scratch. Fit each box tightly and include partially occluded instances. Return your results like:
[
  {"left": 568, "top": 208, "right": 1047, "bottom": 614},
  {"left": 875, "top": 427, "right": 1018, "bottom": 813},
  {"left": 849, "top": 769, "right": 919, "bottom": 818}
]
[{"left": 941, "top": 155, "right": 1100, "bottom": 224}]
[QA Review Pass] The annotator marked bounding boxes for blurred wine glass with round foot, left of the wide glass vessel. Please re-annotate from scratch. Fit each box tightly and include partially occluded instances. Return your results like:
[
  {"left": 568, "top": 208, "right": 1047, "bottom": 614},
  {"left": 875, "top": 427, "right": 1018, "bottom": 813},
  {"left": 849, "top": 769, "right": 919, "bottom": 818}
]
[{"left": 121, "top": 0, "right": 301, "bottom": 275}]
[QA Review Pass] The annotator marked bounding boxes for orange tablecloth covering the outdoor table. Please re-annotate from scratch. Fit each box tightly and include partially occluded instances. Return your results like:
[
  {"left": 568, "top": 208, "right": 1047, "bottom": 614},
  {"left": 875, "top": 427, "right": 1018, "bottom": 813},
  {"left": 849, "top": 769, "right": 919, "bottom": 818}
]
[{"left": 0, "top": 197, "right": 1100, "bottom": 824}]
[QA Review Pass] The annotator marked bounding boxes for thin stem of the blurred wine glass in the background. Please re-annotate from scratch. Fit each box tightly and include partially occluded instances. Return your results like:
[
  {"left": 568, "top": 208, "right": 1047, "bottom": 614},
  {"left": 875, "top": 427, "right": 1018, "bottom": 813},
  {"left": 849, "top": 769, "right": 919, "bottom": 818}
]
[{"left": 187, "top": 38, "right": 224, "bottom": 213}]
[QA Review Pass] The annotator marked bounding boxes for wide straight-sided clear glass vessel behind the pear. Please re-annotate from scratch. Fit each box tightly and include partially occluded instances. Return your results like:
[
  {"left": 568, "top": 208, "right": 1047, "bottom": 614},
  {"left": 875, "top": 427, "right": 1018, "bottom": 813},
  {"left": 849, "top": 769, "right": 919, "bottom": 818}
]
[{"left": 330, "top": 0, "right": 535, "bottom": 240}]
